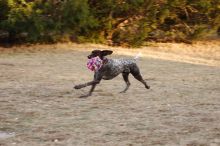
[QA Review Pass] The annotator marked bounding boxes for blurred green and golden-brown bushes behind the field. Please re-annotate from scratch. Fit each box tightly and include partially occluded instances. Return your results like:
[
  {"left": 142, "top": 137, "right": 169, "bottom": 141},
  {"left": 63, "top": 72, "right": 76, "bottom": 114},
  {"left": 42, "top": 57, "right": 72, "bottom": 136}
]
[{"left": 0, "top": 0, "right": 220, "bottom": 46}]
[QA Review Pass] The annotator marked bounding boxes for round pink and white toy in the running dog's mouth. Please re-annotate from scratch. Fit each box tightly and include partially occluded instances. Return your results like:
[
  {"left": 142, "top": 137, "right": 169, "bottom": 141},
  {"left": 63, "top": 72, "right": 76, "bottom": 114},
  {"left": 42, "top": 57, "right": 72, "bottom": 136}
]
[{"left": 87, "top": 56, "right": 103, "bottom": 71}]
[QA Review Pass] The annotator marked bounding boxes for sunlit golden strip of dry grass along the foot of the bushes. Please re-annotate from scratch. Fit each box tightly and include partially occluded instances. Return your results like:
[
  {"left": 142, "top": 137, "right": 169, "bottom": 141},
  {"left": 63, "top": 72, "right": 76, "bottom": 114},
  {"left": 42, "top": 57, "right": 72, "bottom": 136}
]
[{"left": 0, "top": 40, "right": 220, "bottom": 66}]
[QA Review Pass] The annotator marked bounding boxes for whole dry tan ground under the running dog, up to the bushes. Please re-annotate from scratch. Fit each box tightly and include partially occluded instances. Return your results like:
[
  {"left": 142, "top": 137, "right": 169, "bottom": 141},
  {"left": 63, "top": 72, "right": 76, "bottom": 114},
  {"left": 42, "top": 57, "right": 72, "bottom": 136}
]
[{"left": 0, "top": 44, "right": 220, "bottom": 146}]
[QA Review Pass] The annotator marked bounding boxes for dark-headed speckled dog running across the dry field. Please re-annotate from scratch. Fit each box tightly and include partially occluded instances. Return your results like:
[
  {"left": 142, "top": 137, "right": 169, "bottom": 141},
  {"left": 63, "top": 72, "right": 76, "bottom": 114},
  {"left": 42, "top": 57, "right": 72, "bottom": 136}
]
[{"left": 74, "top": 50, "right": 150, "bottom": 97}]
